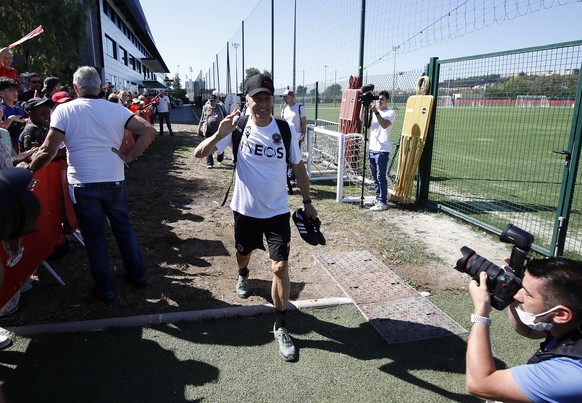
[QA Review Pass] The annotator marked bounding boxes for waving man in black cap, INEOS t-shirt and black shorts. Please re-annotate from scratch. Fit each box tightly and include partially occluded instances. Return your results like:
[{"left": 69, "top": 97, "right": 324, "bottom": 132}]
[{"left": 194, "top": 74, "right": 317, "bottom": 361}]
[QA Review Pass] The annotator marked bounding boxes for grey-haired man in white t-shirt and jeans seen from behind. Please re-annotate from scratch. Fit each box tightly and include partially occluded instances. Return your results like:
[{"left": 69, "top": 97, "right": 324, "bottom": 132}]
[{"left": 28, "top": 66, "right": 156, "bottom": 302}]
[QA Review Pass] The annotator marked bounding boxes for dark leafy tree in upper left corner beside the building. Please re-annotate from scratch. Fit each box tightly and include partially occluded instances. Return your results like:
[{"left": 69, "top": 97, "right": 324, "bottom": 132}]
[{"left": 0, "top": 0, "right": 97, "bottom": 82}]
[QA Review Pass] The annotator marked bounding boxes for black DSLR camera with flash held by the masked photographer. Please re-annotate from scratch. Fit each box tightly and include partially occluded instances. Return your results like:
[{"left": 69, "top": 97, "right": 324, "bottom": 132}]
[{"left": 456, "top": 224, "right": 534, "bottom": 310}]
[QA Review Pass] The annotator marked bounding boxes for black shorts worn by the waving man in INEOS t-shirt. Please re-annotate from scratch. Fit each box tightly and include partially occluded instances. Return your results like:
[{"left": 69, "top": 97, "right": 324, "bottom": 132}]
[{"left": 234, "top": 211, "right": 291, "bottom": 261}]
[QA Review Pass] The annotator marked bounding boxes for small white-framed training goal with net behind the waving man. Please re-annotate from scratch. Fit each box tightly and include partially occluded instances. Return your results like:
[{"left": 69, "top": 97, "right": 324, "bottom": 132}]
[{"left": 304, "top": 119, "right": 375, "bottom": 203}]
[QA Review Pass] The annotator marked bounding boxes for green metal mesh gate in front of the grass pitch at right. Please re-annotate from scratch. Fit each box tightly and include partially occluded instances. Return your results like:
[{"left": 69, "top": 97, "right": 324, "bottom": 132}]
[{"left": 417, "top": 41, "right": 582, "bottom": 258}]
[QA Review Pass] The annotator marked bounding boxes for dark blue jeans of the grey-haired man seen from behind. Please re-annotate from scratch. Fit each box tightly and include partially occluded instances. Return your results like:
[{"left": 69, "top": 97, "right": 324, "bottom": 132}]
[{"left": 69, "top": 181, "right": 146, "bottom": 298}]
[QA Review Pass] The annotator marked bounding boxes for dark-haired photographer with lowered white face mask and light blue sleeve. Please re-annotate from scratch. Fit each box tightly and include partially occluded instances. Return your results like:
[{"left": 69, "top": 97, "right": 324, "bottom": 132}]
[{"left": 466, "top": 249, "right": 582, "bottom": 402}]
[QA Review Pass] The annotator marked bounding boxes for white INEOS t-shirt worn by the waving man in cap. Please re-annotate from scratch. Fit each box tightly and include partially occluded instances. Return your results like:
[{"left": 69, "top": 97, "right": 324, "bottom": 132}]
[{"left": 216, "top": 117, "right": 301, "bottom": 218}]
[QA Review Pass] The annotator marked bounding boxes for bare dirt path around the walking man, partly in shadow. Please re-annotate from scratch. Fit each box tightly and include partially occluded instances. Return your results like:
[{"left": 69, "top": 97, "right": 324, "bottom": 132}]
[{"left": 0, "top": 125, "right": 509, "bottom": 326}]
